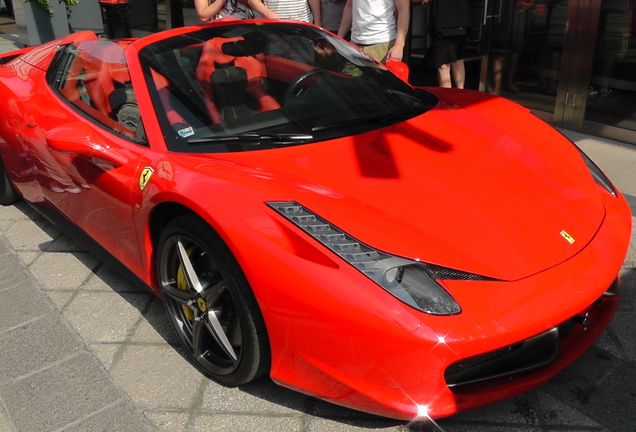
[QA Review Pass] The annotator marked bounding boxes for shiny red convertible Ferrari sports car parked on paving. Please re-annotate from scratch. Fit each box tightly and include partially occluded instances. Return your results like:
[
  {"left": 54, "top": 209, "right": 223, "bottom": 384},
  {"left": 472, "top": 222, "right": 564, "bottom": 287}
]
[{"left": 0, "top": 20, "right": 631, "bottom": 420}]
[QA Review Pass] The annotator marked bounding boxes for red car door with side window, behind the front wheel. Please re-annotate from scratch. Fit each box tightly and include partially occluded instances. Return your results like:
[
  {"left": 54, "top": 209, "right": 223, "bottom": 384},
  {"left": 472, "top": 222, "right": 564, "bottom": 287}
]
[{"left": 23, "top": 40, "right": 148, "bottom": 274}]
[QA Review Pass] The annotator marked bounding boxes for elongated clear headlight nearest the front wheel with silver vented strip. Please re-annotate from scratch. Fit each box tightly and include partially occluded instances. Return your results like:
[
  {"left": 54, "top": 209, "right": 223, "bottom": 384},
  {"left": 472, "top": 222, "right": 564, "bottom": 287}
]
[{"left": 267, "top": 201, "right": 461, "bottom": 315}]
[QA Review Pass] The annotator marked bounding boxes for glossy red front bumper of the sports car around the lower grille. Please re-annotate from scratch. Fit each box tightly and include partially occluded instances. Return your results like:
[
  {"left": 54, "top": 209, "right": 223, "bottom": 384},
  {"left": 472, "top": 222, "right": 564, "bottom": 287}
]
[{"left": 215, "top": 186, "right": 631, "bottom": 420}]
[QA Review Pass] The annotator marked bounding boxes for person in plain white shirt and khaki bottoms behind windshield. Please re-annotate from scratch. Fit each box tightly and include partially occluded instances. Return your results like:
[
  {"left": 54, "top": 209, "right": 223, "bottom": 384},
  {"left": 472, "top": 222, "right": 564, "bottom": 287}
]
[{"left": 338, "top": 0, "right": 410, "bottom": 63}]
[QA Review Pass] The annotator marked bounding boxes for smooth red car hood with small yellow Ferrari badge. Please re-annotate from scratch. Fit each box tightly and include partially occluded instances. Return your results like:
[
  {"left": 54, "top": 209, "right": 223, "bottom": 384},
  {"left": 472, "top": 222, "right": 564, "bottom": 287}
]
[{"left": 191, "top": 90, "right": 605, "bottom": 280}]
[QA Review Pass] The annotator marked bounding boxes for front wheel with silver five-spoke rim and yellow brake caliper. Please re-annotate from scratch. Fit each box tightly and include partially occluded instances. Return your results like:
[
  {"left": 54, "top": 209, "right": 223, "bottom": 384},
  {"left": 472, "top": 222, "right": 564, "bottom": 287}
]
[{"left": 156, "top": 215, "right": 271, "bottom": 386}]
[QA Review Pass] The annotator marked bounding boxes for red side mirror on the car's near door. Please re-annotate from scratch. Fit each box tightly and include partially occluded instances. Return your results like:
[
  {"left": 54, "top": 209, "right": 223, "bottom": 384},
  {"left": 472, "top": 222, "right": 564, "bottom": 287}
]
[{"left": 46, "top": 123, "right": 128, "bottom": 167}]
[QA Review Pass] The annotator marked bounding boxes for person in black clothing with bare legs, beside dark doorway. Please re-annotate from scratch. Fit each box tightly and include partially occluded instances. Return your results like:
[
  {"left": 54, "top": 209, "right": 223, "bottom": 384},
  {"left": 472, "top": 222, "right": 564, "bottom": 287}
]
[{"left": 422, "top": 0, "right": 471, "bottom": 88}]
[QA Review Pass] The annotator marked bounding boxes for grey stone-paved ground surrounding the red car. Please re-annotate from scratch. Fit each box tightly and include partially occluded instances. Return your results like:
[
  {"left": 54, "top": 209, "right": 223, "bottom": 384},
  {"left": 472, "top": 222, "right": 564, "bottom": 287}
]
[{"left": 0, "top": 35, "right": 636, "bottom": 432}]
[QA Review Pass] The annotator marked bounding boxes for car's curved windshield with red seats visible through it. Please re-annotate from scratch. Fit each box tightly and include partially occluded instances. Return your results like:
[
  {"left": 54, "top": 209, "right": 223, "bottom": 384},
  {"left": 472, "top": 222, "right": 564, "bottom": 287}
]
[{"left": 140, "top": 22, "right": 437, "bottom": 152}]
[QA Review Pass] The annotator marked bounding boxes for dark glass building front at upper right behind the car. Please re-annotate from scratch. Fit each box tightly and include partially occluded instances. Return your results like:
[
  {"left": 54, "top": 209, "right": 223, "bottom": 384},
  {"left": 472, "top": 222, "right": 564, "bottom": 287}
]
[{"left": 410, "top": 0, "right": 636, "bottom": 143}]
